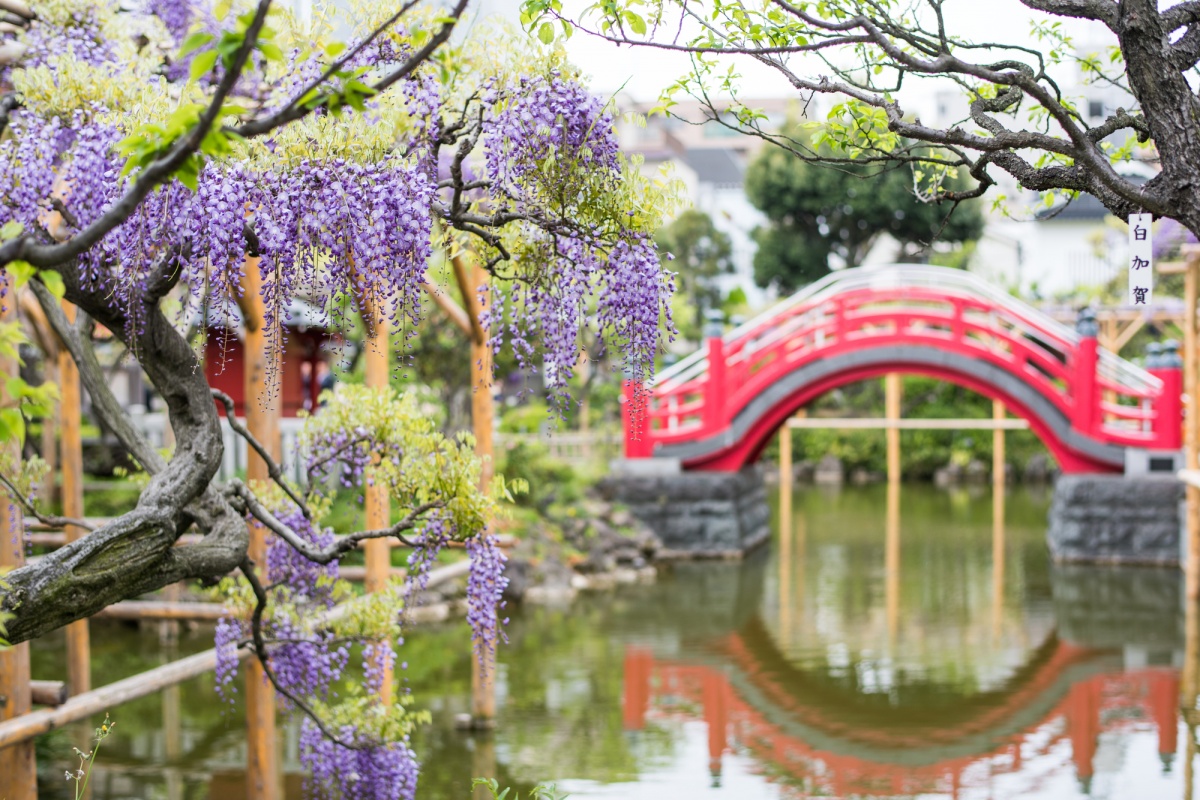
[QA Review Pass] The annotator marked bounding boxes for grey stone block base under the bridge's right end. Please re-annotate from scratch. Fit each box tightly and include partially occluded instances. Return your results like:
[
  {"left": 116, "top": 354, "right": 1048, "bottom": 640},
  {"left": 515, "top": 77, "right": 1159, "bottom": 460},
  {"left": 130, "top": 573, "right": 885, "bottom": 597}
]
[{"left": 1046, "top": 475, "right": 1183, "bottom": 565}]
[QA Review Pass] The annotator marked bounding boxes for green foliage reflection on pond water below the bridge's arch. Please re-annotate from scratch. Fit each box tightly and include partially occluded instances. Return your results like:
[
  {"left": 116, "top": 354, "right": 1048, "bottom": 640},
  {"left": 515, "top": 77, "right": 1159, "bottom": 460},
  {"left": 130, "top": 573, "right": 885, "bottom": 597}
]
[{"left": 761, "top": 485, "right": 1054, "bottom": 697}]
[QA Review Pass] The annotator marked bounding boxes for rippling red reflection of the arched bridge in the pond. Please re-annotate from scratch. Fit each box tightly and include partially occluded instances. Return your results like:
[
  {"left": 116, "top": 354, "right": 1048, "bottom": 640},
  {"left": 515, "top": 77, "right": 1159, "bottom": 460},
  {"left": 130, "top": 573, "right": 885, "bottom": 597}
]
[{"left": 624, "top": 634, "right": 1180, "bottom": 798}]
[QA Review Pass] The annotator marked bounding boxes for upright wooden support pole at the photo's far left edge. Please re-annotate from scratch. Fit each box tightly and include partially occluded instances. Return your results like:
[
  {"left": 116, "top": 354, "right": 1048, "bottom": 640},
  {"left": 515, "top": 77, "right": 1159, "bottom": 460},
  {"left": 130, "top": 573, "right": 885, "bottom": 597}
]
[{"left": 0, "top": 299, "right": 37, "bottom": 800}]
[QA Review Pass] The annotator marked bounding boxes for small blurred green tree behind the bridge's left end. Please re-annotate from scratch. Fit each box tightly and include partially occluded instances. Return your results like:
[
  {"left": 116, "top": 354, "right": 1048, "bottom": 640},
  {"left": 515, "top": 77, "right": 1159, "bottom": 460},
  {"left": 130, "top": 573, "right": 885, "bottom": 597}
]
[{"left": 655, "top": 209, "right": 733, "bottom": 341}]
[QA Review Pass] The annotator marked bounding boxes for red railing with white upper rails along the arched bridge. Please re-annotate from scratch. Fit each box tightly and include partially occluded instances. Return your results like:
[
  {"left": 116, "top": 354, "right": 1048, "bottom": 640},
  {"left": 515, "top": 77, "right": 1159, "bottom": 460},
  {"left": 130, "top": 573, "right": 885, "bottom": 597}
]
[{"left": 628, "top": 265, "right": 1180, "bottom": 457}]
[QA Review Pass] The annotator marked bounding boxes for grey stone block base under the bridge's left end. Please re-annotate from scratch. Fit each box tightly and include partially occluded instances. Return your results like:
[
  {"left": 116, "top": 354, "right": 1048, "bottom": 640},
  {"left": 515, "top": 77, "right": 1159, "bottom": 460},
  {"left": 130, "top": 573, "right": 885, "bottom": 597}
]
[{"left": 596, "top": 465, "right": 770, "bottom": 558}]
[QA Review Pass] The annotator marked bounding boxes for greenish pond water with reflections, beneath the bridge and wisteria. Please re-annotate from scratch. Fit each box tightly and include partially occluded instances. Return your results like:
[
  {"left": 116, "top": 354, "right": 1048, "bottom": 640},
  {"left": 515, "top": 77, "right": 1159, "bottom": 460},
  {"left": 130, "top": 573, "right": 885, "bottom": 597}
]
[{"left": 23, "top": 486, "right": 1194, "bottom": 800}]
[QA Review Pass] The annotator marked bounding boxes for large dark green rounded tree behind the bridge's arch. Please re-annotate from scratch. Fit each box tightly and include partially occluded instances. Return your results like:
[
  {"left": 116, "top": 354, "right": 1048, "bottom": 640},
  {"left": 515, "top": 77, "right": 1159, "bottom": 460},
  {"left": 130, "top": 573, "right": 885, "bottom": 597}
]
[{"left": 745, "top": 141, "right": 983, "bottom": 291}]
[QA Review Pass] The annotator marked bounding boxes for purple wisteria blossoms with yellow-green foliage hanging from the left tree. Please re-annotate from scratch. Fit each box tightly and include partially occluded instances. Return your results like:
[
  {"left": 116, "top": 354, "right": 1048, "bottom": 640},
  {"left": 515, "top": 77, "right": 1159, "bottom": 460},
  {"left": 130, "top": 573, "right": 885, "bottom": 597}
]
[{"left": 0, "top": 0, "right": 673, "bottom": 799}]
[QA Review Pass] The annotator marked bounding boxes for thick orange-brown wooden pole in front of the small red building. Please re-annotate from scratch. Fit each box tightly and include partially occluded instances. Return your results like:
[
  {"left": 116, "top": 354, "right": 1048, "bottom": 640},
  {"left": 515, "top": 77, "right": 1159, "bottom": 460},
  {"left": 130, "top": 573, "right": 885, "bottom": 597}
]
[{"left": 240, "top": 257, "right": 282, "bottom": 800}]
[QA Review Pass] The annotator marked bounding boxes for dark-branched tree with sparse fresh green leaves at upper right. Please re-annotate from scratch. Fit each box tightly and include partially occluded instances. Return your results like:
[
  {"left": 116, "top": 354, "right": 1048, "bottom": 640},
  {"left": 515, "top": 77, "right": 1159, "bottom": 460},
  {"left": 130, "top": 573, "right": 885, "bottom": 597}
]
[{"left": 523, "top": 0, "right": 1200, "bottom": 247}]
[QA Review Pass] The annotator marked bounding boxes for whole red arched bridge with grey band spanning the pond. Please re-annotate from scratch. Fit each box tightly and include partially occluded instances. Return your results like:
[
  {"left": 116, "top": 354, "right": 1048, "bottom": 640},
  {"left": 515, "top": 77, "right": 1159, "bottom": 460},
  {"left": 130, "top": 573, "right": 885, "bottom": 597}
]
[{"left": 625, "top": 265, "right": 1182, "bottom": 473}]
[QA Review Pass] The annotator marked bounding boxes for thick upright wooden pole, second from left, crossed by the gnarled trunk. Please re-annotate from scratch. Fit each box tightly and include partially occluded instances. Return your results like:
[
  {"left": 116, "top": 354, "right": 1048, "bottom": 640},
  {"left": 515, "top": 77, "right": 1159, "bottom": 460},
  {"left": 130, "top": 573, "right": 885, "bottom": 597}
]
[{"left": 59, "top": 301, "right": 91, "bottom": 694}]
